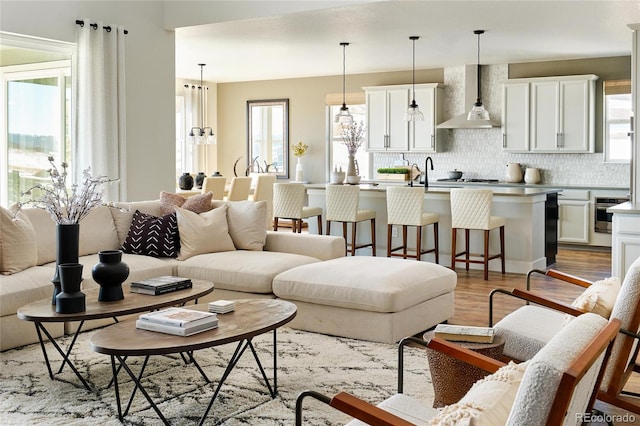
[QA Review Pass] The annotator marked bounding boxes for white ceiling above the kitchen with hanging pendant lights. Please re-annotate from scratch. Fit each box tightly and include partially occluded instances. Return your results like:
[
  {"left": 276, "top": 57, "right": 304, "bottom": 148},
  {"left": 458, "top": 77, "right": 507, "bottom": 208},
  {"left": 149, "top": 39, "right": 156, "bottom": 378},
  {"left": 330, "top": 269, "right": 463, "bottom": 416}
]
[{"left": 176, "top": 0, "right": 640, "bottom": 83}]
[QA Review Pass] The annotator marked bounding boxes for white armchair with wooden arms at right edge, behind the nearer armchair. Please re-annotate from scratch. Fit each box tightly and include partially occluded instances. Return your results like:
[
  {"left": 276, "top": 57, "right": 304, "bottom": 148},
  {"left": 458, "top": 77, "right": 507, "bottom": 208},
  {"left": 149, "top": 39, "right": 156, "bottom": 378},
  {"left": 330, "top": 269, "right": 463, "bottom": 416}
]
[{"left": 489, "top": 258, "right": 640, "bottom": 414}]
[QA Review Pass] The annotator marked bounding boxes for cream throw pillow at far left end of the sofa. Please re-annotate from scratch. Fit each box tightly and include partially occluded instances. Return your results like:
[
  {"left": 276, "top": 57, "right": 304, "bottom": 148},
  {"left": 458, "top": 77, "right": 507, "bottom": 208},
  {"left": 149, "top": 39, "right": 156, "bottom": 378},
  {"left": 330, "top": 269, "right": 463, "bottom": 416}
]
[{"left": 0, "top": 207, "right": 38, "bottom": 275}]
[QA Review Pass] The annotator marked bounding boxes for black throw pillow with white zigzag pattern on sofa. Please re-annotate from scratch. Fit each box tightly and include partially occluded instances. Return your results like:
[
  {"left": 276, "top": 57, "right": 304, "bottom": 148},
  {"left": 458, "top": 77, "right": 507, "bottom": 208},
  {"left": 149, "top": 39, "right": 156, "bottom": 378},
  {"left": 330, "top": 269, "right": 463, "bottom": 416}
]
[{"left": 122, "top": 210, "right": 179, "bottom": 257}]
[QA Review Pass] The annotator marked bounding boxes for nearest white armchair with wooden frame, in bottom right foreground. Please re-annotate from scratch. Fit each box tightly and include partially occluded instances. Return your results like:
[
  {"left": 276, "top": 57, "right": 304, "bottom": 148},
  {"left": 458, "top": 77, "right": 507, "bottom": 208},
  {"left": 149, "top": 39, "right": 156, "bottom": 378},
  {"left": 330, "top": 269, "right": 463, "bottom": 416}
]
[{"left": 296, "top": 313, "right": 620, "bottom": 426}]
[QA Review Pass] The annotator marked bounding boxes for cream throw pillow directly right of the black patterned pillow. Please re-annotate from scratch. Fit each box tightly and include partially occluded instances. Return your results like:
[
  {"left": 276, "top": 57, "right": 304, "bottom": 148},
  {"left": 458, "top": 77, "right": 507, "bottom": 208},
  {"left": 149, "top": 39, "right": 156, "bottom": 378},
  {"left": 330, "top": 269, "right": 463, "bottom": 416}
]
[{"left": 176, "top": 205, "right": 236, "bottom": 260}]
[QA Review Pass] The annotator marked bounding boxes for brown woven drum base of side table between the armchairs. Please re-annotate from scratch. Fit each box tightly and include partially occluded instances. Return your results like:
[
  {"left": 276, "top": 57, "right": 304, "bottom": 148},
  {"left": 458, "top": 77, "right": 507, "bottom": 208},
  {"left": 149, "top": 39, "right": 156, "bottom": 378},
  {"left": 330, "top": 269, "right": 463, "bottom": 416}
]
[{"left": 423, "top": 331, "right": 504, "bottom": 408}]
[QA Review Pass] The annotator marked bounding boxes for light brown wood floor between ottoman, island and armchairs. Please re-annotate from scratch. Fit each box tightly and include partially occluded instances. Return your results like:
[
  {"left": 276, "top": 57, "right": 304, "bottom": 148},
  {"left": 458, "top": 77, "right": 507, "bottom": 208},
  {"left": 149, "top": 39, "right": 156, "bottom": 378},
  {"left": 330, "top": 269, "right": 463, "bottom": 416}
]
[{"left": 449, "top": 249, "right": 640, "bottom": 425}]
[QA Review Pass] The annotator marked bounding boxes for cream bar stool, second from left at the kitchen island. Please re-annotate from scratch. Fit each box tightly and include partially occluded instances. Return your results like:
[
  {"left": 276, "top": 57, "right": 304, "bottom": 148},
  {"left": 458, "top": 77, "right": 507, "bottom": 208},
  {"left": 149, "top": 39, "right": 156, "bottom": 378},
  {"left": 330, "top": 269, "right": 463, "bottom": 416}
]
[{"left": 326, "top": 185, "right": 376, "bottom": 256}]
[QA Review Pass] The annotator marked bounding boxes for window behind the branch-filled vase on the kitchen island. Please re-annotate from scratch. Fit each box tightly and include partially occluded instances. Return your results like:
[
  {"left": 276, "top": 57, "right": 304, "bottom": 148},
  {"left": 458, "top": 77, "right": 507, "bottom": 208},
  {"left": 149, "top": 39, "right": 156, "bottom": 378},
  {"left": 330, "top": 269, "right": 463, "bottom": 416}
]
[{"left": 327, "top": 104, "right": 373, "bottom": 180}]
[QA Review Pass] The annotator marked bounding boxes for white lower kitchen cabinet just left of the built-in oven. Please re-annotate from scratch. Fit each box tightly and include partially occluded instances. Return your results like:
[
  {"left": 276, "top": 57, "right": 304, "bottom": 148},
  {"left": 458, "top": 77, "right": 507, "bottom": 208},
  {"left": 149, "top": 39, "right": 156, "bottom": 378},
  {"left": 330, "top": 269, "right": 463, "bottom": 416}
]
[{"left": 558, "top": 190, "right": 592, "bottom": 244}]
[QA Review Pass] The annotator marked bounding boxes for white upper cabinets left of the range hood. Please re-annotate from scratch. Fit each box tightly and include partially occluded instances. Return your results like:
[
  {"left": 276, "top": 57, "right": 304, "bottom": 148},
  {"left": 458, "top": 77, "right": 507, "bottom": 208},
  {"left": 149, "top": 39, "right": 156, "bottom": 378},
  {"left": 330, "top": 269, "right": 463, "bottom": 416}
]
[{"left": 364, "top": 84, "right": 443, "bottom": 152}]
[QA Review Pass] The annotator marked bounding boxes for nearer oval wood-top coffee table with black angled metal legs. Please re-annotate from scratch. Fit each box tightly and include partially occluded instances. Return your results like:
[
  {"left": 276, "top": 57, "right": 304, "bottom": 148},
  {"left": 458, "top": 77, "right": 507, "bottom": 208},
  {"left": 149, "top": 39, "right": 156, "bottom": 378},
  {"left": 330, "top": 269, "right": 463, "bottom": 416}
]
[{"left": 90, "top": 299, "right": 297, "bottom": 424}]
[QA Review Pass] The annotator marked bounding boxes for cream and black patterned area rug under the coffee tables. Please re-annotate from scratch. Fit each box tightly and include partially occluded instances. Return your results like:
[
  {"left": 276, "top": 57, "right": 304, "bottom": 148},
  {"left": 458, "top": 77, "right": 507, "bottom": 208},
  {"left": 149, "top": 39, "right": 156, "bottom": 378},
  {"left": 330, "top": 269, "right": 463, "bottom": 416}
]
[{"left": 0, "top": 327, "right": 433, "bottom": 426}]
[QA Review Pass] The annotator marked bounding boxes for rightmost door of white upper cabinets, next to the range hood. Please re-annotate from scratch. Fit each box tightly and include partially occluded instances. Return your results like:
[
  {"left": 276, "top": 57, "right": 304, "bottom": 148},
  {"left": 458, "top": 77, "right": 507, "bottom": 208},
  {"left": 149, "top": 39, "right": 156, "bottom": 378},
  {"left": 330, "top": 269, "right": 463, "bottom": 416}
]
[{"left": 409, "top": 84, "right": 444, "bottom": 152}]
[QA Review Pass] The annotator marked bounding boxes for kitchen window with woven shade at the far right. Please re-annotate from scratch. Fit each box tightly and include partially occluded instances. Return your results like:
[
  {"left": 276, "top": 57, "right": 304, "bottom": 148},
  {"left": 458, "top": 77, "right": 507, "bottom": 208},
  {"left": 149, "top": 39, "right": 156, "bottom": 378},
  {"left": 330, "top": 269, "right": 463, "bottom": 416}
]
[{"left": 604, "top": 80, "right": 632, "bottom": 163}]
